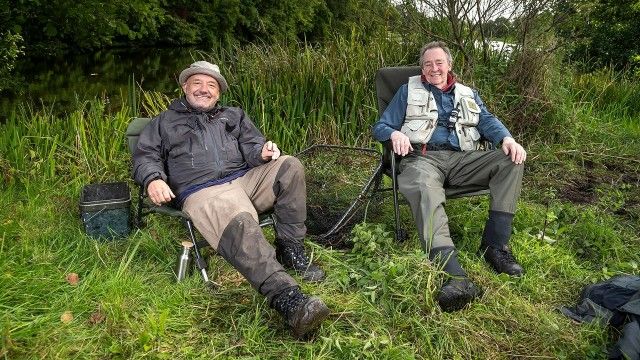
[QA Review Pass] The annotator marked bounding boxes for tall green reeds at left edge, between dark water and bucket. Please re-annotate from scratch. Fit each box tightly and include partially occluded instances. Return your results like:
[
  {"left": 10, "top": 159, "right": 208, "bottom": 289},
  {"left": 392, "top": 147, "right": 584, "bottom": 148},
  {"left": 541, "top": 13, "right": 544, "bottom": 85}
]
[{"left": 0, "top": 99, "right": 131, "bottom": 190}]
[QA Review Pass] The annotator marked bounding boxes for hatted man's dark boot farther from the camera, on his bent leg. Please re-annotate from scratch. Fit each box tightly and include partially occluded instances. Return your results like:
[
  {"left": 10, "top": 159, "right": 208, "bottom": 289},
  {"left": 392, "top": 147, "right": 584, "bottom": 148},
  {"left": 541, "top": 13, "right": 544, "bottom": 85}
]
[{"left": 275, "top": 239, "right": 325, "bottom": 282}]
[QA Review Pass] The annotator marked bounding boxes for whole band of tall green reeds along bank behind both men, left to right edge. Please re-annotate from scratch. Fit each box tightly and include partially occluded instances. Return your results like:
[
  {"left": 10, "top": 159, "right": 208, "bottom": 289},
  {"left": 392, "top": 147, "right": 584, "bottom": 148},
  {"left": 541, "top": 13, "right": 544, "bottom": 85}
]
[{"left": 0, "top": 35, "right": 640, "bottom": 188}]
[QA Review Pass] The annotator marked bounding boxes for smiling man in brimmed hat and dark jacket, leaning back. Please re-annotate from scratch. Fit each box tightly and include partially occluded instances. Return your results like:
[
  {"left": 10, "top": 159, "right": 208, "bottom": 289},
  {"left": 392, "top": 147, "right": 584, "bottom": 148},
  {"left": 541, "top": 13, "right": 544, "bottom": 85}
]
[{"left": 133, "top": 61, "right": 329, "bottom": 336}]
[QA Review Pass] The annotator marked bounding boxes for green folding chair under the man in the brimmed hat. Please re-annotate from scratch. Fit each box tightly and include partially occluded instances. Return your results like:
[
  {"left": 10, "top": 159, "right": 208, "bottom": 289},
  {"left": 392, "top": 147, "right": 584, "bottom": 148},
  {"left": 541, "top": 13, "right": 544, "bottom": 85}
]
[{"left": 126, "top": 118, "right": 275, "bottom": 284}]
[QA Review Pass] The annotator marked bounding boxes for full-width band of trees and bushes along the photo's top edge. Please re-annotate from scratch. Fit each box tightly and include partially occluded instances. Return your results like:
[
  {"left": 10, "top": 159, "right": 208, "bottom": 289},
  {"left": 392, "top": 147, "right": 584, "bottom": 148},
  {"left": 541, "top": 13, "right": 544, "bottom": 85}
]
[{"left": 0, "top": 0, "right": 640, "bottom": 93}]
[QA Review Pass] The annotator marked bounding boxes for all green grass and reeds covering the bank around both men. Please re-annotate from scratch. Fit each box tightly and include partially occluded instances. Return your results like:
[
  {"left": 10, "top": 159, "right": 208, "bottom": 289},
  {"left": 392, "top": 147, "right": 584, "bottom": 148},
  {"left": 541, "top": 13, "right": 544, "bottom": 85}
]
[{"left": 0, "top": 40, "right": 640, "bottom": 359}]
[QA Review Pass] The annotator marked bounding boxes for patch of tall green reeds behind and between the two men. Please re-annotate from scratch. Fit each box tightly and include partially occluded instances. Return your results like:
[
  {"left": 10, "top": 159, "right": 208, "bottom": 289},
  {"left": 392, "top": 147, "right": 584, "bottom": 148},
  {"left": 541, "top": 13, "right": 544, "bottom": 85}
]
[{"left": 143, "top": 36, "right": 419, "bottom": 153}]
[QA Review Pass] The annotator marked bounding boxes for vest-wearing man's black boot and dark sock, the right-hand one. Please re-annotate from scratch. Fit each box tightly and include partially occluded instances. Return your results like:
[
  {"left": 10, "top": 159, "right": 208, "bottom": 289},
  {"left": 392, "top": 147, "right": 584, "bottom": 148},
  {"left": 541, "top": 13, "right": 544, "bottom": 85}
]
[{"left": 479, "top": 211, "right": 524, "bottom": 276}]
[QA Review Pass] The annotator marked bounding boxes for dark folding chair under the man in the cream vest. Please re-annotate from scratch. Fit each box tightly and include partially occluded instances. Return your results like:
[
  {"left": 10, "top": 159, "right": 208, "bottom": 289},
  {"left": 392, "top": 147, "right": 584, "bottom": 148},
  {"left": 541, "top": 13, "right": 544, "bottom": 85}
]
[{"left": 373, "top": 66, "right": 491, "bottom": 241}]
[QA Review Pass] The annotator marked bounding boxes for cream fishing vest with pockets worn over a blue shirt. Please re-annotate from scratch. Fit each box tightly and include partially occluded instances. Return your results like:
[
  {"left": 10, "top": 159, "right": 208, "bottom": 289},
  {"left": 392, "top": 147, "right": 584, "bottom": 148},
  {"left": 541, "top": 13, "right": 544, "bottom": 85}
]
[{"left": 400, "top": 75, "right": 480, "bottom": 151}]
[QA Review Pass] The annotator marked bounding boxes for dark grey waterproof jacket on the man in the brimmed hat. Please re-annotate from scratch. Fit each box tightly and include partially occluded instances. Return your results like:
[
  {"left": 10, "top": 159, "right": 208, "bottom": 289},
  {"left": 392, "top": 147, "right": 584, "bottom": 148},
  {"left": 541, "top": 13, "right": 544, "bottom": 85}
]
[{"left": 133, "top": 97, "right": 266, "bottom": 198}]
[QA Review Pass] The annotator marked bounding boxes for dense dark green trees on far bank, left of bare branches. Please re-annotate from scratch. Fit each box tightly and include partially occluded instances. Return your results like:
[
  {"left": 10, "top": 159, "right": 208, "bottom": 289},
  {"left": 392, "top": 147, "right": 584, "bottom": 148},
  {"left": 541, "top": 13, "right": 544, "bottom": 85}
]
[{"left": 0, "top": 0, "right": 398, "bottom": 55}]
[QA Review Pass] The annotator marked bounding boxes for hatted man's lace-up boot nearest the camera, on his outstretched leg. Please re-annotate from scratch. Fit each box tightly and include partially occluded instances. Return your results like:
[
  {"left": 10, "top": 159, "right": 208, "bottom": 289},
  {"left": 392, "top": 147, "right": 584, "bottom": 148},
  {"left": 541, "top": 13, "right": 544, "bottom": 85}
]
[{"left": 271, "top": 287, "right": 329, "bottom": 338}]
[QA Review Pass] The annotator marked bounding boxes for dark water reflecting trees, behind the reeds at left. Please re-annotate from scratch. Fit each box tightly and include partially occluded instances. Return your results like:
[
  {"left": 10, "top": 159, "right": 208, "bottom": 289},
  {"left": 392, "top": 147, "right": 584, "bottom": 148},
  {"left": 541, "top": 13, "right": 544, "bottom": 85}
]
[{"left": 0, "top": 48, "right": 198, "bottom": 122}]
